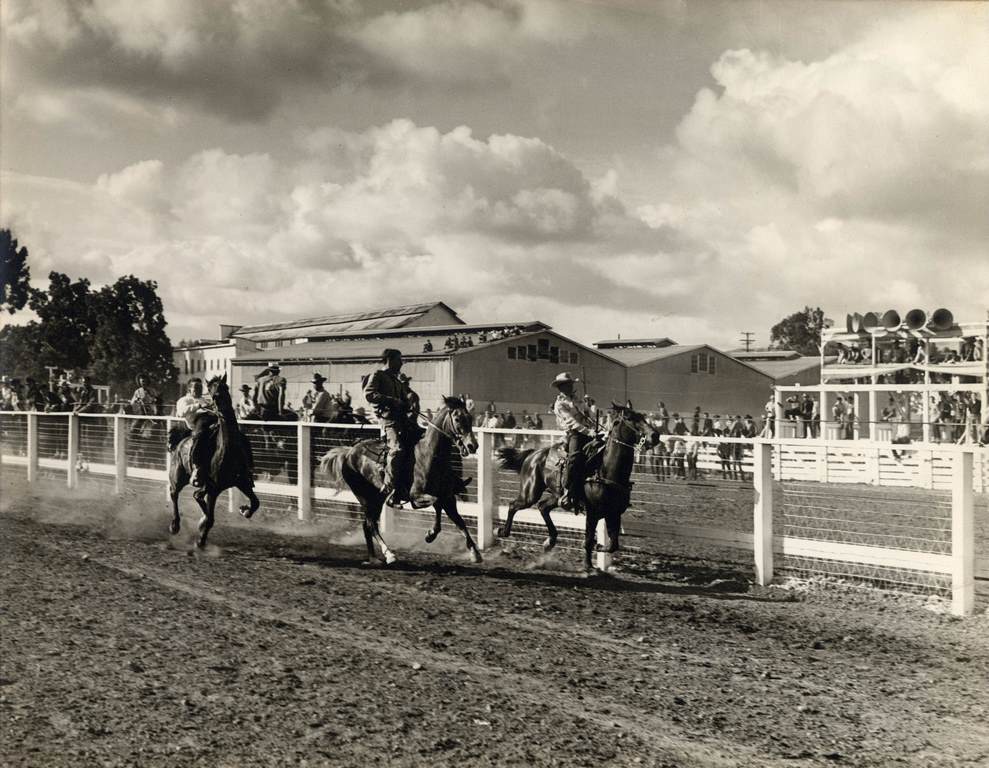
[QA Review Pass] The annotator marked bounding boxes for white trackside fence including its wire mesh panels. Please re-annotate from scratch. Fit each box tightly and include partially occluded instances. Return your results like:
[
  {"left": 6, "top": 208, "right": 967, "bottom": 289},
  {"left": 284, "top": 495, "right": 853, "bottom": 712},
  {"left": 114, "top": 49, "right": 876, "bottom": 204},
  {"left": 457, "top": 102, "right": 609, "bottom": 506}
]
[{"left": 0, "top": 412, "right": 989, "bottom": 614}]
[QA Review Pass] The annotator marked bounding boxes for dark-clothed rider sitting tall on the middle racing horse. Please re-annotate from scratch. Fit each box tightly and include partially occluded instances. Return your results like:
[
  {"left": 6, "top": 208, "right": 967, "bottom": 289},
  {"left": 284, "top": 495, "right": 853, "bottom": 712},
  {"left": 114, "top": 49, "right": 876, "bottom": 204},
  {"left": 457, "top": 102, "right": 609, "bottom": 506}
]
[{"left": 364, "top": 349, "right": 423, "bottom": 506}]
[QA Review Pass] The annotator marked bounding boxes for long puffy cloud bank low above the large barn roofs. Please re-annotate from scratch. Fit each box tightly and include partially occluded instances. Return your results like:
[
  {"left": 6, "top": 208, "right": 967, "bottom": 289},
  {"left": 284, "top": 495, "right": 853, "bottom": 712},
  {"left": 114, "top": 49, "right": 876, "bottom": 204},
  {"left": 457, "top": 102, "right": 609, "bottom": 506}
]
[{"left": 3, "top": 120, "right": 679, "bottom": 342}]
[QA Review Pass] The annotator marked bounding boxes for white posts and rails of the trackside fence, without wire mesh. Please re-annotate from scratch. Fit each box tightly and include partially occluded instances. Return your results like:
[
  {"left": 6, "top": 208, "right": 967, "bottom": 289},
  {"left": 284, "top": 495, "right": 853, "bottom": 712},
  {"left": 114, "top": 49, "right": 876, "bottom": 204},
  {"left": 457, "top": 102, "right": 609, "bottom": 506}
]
[{"left": 0, "top": 412, "right": 989, "bottom": 614}]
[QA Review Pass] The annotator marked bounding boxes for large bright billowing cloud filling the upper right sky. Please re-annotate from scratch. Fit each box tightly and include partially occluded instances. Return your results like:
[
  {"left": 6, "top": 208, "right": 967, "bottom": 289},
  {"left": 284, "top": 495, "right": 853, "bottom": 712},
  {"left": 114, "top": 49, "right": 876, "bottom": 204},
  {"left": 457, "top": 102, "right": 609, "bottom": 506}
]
[{"left": 637, "top": 5, "right": 989, "bottom": 336}]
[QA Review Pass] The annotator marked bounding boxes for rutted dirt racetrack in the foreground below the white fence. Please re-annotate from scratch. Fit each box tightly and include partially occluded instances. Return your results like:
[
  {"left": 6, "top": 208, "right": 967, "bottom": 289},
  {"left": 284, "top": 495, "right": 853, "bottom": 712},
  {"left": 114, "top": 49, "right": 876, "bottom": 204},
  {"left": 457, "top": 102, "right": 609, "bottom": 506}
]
[{"left": 0, "top": 476, "right": 989, "bottom": 766}]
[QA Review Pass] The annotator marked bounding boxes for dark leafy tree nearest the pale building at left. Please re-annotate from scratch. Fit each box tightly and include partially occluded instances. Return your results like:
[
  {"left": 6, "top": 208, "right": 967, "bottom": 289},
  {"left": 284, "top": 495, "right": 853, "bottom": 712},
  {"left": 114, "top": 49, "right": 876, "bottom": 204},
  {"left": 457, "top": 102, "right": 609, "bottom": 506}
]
[{"left": 90, "top": 275, "right": 178, "bottom": 391}]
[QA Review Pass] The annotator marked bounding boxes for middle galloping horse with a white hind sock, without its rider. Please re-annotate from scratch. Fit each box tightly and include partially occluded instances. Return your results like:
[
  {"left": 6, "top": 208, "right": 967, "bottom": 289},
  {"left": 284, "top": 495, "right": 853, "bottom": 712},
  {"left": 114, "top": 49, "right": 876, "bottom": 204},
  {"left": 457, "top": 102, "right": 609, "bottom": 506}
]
[{"left": 320, "top": 397, "right": 481, "bottom": 563}]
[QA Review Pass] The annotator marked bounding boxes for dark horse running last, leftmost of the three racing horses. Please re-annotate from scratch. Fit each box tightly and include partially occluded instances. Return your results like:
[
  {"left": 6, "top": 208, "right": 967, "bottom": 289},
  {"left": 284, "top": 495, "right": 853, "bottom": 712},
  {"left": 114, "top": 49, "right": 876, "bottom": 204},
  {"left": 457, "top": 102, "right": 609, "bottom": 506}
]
[{"left": 168, "top": 374, "right": 261, "bottom": 549}]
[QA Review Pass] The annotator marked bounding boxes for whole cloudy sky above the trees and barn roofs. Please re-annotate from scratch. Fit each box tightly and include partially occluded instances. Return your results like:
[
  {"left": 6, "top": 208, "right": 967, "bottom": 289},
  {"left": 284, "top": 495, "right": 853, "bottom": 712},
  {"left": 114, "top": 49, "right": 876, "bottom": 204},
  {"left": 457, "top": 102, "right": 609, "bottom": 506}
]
[{"left": 0, "top": 0, "right": 989, "bottom": 348}]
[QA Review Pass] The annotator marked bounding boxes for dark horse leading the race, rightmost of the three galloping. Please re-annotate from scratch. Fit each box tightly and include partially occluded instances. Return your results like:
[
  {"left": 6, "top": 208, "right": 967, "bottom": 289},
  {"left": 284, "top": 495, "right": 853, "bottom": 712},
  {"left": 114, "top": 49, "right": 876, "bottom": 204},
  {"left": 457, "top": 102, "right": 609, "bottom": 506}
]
[{"left": 497, "top": 402, "right": 659, "bottom": 571}]
